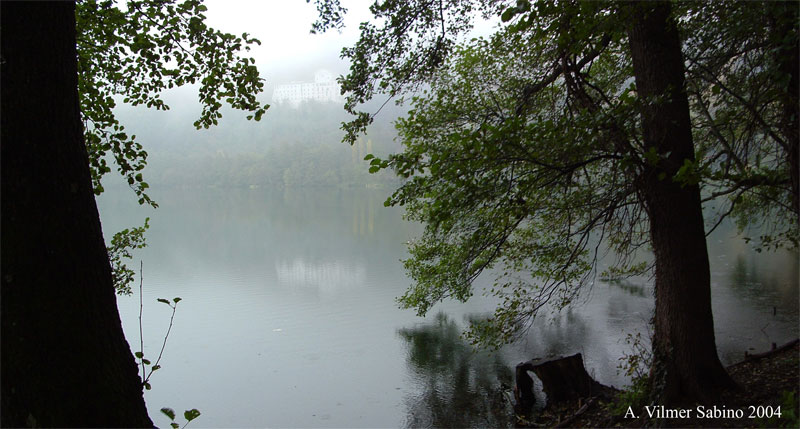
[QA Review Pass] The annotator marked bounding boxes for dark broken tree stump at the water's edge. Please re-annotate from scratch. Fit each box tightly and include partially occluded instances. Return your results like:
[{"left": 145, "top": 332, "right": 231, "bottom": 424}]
[{"left": 517, "top": 353, "right": 613, "bottom": 405}]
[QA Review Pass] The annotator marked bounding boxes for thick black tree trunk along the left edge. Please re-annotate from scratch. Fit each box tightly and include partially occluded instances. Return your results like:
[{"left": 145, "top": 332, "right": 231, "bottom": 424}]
[{"left": 0, "top": 2, "right": 152, "bottom": 427}]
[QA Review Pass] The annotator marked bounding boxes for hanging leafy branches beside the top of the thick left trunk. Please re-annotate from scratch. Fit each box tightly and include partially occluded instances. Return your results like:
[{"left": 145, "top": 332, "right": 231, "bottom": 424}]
[{"left": 76, "top": 0, "right": 268, "bottom": 206}]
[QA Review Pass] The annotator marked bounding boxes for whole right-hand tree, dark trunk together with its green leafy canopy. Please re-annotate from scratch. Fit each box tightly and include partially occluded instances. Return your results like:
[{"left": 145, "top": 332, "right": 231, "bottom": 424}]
[{"left": 316, "top": 0, "right": 800, "bottom": 399}]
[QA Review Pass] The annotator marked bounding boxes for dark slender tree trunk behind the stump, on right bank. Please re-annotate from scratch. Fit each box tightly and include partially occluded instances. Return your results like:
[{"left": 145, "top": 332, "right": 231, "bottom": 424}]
[{"left": 629, "top": 2, "right": 733, "bottom": 404}]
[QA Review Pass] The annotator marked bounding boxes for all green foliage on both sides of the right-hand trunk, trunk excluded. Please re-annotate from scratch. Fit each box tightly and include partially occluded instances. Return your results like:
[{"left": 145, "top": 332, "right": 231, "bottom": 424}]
[{"left": 318, "top": 0, "right": 798, "bottom": 346}]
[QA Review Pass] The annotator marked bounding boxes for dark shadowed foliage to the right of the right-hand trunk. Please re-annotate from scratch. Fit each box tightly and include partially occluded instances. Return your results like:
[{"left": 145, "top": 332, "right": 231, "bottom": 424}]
[{"left": 683, "top": 2, "right": 800, "bottom": 251}]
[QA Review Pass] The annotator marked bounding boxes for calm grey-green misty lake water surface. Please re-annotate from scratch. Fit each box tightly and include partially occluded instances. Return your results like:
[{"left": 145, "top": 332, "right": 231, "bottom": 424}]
[{"left": 98, "top": 188, "right": 799, "bottom": 428}]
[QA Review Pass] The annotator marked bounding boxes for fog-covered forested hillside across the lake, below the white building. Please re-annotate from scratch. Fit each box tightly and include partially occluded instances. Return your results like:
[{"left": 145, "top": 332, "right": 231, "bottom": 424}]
[{"left": 109, "top": 84, "right": 399, "bottom": 187}]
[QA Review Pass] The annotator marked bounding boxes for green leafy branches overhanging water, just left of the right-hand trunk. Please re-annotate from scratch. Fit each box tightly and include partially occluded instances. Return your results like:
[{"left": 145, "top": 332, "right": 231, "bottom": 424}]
[{"left": 373, "top": 6, "right": 648, "bottom": 346}]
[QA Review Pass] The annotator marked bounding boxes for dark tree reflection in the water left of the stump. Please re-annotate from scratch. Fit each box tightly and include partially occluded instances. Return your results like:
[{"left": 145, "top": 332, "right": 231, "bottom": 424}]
[{"left": 398, "top": 313, "right": 513, "bottom": 428}]
